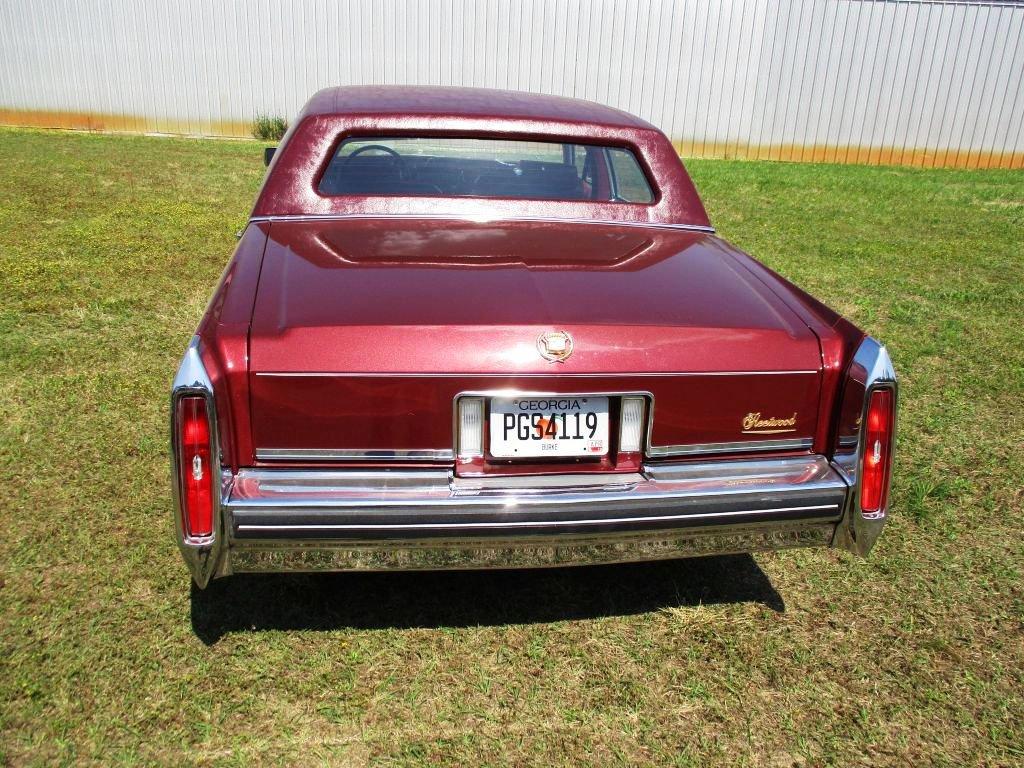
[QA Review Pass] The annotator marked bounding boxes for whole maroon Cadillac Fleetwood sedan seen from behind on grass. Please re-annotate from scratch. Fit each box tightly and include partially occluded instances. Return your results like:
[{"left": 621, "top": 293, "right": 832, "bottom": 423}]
[{"left": 171, "top": 87, "right": 896, "bottom": 587}]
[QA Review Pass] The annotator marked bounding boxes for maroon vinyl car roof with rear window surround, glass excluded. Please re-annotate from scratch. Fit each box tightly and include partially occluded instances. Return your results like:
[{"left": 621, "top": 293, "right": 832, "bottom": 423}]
[{"left": 252, "top": 85, "right": 711, "bottom": 229}]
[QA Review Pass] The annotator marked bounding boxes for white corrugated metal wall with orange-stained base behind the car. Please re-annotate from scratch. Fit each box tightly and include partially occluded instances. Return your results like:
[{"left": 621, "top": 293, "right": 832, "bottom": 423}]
[{"left": 0, "top": 0, "right": 1024, "bottom": 168}]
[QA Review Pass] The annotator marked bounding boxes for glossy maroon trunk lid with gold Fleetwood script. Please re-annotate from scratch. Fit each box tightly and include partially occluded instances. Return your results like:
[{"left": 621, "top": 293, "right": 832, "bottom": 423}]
[{"left": 250, "top": 218, "right": 821, "bottom": 466}]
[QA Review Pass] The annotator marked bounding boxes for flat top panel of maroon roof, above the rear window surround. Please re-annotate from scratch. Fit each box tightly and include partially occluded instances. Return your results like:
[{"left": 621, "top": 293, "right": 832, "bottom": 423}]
[{"left": 301, "top": 85, "right": 657, "bottom": 130}]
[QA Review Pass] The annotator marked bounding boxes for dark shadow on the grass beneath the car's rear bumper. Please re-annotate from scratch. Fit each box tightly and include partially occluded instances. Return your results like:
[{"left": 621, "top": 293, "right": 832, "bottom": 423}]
[{"left": 191, "top": 555, "right": 785, "bottom": 645}]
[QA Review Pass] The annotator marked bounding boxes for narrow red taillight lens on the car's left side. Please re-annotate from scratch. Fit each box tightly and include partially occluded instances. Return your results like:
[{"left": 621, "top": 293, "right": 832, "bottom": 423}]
[{"left": 175, "top": 397, "right": 214, "bottom": 537}]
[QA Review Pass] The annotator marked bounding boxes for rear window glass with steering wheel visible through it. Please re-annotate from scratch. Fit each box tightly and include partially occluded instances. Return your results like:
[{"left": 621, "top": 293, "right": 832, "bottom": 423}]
[{"left": 319, "top": 136, "right": 654, "bottom": 203}]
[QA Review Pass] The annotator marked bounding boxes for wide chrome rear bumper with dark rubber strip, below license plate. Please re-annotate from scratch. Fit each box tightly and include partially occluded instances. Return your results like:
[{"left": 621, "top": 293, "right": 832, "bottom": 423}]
[{"left": 182, "top": 456, "right": 849, "bottom": 586}]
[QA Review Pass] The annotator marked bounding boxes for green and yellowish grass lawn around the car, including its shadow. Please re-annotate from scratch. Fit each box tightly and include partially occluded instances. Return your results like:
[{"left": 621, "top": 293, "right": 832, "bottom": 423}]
[{"left": 0, "top": 129, "right": 1024, "bottom": 766}]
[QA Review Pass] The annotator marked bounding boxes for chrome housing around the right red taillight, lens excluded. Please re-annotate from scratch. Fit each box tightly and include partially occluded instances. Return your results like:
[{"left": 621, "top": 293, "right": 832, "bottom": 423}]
[{"left": 833, "top": 336, "right": 899, "bottom": 557}]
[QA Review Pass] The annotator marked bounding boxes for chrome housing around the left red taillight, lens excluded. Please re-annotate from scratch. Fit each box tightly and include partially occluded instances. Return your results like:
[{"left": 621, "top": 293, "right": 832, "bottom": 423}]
[{"left": 170, "top": 336, "right": 229, "bottom": 587}]
